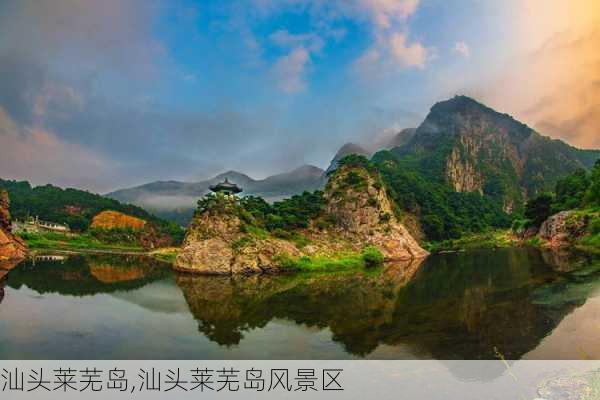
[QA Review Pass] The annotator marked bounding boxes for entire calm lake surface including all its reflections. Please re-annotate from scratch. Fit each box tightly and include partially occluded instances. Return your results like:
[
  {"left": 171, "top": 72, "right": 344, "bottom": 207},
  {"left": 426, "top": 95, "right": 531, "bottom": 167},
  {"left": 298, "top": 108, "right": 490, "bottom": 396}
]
[{"left": 0, "top": 249, "right": 600, "bottom": 359}]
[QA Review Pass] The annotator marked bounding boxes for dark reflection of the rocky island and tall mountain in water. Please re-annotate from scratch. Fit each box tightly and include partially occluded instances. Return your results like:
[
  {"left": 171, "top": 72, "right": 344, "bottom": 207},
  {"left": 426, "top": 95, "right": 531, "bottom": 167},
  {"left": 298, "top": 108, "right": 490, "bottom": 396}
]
[{"left": 176, "top": 250, "right": 598, "bottom": 359}]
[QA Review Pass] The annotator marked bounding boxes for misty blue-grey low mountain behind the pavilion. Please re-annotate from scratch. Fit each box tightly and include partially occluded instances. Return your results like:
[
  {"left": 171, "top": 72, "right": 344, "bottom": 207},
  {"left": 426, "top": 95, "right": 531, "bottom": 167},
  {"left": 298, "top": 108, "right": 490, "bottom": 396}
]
[{"left": 106, "top": 165, "right": 324, "bottom": 225}]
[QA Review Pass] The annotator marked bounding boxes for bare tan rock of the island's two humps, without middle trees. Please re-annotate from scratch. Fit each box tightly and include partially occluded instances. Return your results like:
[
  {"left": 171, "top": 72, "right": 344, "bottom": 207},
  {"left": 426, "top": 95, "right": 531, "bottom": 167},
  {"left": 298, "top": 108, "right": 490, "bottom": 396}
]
[{"left": 175, "top": 162, "right": 428, "bottom": 274}]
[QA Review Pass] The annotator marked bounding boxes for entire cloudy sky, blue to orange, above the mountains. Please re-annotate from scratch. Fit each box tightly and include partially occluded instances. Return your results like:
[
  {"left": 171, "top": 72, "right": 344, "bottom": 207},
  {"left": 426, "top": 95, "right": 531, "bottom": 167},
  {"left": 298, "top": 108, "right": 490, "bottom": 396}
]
[{"left": 0, "top": 0, "right": 600, "bottom": 193}]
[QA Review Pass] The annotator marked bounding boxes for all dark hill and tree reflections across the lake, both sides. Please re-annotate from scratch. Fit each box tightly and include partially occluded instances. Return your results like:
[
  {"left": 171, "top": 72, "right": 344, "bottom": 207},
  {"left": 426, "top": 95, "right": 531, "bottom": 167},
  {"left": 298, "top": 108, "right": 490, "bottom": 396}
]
[{"left": 0, "top": 249, "right": 600, "bottom": 359}]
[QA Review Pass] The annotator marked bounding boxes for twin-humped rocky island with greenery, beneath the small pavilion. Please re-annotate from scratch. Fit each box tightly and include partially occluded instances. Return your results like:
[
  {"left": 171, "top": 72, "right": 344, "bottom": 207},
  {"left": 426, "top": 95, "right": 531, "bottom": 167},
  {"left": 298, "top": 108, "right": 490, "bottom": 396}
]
[{"left": 174, "top": 155, "right": 429, "bottom": 275}]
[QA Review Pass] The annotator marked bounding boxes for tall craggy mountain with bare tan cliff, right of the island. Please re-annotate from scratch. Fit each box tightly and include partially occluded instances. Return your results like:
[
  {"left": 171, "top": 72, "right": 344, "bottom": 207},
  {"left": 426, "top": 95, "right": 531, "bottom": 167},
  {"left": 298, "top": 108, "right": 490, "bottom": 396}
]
[{"left": 392, "top": 96, "right": 600, "bottom": 213}]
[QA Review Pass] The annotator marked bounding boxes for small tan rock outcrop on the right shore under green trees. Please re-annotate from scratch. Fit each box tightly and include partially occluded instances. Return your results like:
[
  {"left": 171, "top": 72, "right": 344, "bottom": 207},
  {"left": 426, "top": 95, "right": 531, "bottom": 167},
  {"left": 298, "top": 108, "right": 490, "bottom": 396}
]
[{"left": 539, "top": 211, "right": 586, "bottom": 247}]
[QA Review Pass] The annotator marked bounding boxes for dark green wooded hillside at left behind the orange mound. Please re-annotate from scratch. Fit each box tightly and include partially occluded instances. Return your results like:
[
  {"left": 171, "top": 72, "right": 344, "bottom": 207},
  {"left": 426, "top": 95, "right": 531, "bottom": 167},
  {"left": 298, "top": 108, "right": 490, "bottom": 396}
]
[{"left": 0, "top": 179, "right": 184, "bottom": 242}]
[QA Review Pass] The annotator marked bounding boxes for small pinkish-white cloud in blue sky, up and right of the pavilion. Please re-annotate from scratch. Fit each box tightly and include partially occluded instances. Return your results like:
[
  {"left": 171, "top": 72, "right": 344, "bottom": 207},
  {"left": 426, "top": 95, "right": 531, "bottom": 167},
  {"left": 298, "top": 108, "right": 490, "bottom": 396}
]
[{"left": 272, "top": 47, "right": 310, "bottom": 94}]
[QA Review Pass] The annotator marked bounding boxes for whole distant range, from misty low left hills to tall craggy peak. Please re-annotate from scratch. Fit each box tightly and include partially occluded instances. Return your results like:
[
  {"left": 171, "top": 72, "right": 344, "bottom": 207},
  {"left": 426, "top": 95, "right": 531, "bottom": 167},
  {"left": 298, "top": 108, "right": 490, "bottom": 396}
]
[{"left": 106, "top": 96, "right": 600, "bottom": 225}]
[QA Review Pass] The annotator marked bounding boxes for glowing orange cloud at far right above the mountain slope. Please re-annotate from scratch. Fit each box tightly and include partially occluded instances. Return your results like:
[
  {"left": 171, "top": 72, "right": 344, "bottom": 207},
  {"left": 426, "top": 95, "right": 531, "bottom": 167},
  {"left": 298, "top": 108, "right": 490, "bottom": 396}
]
[{"left": 473, "top": 20, "right": 600, "bottom": 148}]
